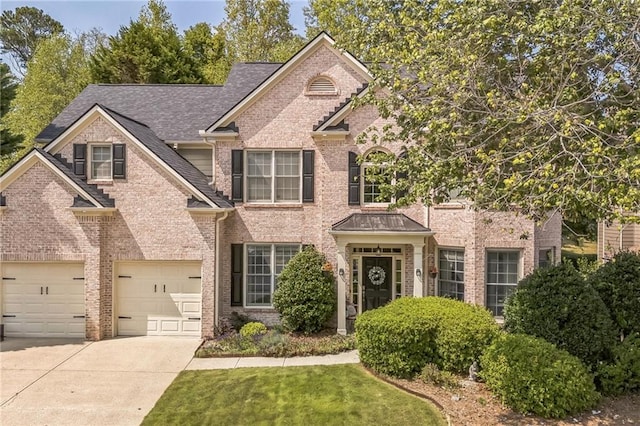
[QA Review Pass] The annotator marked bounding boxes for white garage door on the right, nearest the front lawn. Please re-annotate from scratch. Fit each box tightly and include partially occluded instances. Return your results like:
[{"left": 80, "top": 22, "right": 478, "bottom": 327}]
[{"left": 115, "top": 262, "right": 202, "bottom": 336}]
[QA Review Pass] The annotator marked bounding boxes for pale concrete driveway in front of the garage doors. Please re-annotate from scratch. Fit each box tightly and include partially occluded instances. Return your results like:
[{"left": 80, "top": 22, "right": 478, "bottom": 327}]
[{"left": 0, "top": 337, "right": 200, "bottom": 426}]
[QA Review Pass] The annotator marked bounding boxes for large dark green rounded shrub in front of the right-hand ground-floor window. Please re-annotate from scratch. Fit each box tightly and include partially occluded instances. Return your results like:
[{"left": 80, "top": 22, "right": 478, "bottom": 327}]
[{"left": 504, "top": 263, "right": 616, "bottom": 367}]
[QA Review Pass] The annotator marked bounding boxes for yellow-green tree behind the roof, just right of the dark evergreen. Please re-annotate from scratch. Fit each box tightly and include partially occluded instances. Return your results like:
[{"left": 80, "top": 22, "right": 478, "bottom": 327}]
[{"left": 183, "top": 22, "right": 232, "bottom": 84}]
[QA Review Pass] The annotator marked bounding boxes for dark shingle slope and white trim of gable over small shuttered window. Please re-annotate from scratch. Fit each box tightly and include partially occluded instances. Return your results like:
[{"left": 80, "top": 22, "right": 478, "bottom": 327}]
[{"left": 44, "top": 105, "right": 233, "bottom": 209}]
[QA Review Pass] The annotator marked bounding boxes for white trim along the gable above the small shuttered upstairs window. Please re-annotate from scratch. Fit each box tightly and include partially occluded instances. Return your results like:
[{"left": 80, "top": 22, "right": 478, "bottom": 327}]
[{"left": 44, "top": 105, "right": 221, "bottom": 210}]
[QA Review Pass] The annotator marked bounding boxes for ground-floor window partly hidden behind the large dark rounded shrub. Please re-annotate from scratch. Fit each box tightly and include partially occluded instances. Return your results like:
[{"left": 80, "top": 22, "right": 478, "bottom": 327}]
[{"left": 487, "top": 251, "right": 520, "bottom": 316}]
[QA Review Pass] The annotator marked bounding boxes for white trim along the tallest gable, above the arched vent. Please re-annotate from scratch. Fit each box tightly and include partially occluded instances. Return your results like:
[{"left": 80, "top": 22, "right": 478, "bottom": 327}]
[{"left": 205, "top": 32, "right": 373, "bottom": 134}]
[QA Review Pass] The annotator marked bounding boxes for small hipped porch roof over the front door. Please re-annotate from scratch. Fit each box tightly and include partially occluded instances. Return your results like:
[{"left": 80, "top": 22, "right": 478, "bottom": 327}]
[{"left": 331, "top": 213, "right": 430, "bottom": 232}]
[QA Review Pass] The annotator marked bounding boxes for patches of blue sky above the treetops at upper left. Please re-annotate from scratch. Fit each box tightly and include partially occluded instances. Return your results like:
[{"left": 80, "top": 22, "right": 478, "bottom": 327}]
[{"left": 0, "top": 0, "right": 308, "bottom": 70}]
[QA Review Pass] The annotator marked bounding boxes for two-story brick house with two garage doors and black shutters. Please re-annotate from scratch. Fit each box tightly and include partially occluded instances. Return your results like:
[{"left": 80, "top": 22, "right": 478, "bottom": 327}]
[{"left": 0, "top": 34, "right": 561, "bottom": 339}]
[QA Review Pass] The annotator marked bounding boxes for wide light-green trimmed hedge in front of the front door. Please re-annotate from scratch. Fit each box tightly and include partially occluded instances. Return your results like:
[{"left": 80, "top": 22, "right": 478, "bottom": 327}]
[{"left": 355, "top": 297, "right": 498, "bottom": 378}]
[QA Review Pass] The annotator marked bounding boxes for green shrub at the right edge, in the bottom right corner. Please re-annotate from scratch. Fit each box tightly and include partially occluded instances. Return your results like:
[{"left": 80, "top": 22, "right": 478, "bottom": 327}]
[{"left": 596, "top": 333, "right": 640, "bottom": 396}]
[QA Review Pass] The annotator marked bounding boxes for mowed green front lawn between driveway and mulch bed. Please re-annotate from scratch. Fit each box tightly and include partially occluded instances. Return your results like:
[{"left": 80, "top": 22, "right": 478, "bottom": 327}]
[{"left": 143, "top": 365, "right": 446, "bottom": 426}]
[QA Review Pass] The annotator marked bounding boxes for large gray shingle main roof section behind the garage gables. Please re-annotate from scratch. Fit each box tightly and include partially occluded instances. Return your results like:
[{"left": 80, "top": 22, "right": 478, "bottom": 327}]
[{"left": 36, "top": 63, "right": 281, "bottom": 142}]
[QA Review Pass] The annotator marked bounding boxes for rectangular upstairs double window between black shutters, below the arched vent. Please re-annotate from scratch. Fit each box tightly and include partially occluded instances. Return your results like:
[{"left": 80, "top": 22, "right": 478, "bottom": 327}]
[{"left": 246, "top": 151, "right": 302, "bottom": 203}]
